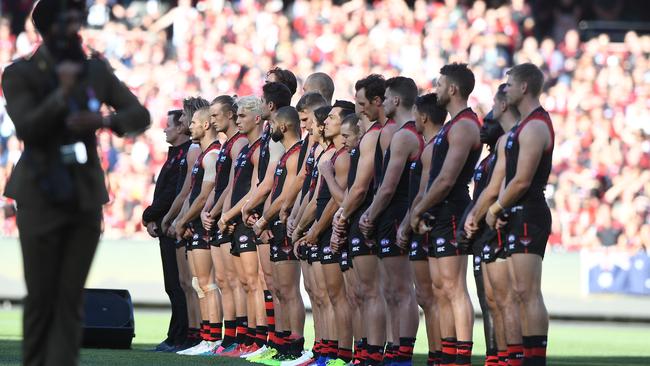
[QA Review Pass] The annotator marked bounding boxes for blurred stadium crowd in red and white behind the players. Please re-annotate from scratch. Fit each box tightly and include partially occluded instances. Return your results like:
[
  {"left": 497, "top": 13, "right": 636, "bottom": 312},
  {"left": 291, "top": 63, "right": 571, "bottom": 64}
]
[{"left": 0, "top": 0, "right": 650, "bottom": 253}]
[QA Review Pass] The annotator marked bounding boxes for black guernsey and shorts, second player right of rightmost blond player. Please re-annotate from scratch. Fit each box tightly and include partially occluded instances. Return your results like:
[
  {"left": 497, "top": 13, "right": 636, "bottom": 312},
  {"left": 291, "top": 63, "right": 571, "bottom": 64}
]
[{"left": 269, "top": 141, "right": 307, "bottom": 262}]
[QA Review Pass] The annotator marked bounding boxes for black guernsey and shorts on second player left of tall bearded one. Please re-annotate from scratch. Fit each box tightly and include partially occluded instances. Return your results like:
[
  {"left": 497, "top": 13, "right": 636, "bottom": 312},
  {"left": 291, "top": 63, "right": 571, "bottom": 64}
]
[{"left": 376, "top": 121, "right": 424, "bottom": 258}]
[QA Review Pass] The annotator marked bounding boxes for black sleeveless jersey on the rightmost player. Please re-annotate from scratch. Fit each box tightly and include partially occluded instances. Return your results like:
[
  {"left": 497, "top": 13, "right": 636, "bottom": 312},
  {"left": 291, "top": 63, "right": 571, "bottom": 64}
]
[{"left": 505, "top": 107, "right": 555, "bottom": 205}]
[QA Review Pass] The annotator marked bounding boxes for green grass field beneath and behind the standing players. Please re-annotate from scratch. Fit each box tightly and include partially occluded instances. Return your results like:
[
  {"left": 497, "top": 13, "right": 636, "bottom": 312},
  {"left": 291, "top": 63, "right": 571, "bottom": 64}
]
[{"left": 0, "top": 309, "right": 650, "bottom": 366}]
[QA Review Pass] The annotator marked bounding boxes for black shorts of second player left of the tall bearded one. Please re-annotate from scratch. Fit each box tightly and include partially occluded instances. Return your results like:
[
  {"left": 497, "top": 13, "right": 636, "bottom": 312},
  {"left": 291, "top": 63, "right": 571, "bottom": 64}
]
[{"left": 375, "top": 203, "right": 408, "bottom": 258}]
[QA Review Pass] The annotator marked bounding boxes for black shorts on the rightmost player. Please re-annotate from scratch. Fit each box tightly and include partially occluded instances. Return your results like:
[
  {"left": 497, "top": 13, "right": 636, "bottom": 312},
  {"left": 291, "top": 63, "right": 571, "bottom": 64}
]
[{"left": 504, "top": 202, "right": 551, "bottom": 258}]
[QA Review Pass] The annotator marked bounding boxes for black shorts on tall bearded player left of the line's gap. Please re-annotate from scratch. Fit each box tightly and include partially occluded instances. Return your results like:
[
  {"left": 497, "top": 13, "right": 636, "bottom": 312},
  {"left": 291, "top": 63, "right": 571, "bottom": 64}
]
[{"left": 429, "top": 200, "right": 471, "bottom": 258}]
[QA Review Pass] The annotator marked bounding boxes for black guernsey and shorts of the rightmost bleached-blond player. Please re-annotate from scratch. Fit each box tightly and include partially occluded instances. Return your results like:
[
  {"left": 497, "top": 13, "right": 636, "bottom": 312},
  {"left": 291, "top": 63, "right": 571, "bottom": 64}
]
[{"left": 230, "top": 138, "right": 262, "bottom": 256}]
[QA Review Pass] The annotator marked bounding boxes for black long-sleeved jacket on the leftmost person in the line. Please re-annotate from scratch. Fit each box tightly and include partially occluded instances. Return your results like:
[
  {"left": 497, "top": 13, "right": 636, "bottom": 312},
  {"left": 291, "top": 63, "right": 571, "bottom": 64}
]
[{"left": 142, "top": 140, "right": 192, "bottom": 224}]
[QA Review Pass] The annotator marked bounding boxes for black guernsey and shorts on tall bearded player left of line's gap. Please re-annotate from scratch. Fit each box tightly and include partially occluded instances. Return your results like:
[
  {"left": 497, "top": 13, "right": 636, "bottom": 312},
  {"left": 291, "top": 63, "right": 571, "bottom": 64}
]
[{"left": 427, "top": 108, "right": 482, "bottom": 257}]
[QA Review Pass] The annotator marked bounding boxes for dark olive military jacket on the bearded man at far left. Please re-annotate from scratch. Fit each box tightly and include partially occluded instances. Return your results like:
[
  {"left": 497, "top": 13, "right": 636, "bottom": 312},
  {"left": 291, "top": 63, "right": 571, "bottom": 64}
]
[{"left": 2, "top": 46, "right": 150, "bottom": 211}]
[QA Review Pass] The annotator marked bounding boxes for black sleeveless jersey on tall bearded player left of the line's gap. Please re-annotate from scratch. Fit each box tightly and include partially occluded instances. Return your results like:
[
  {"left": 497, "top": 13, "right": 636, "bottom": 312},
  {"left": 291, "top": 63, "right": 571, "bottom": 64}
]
[{"left": 427, "top": 108, "right": 483, "bottom": 201}]
